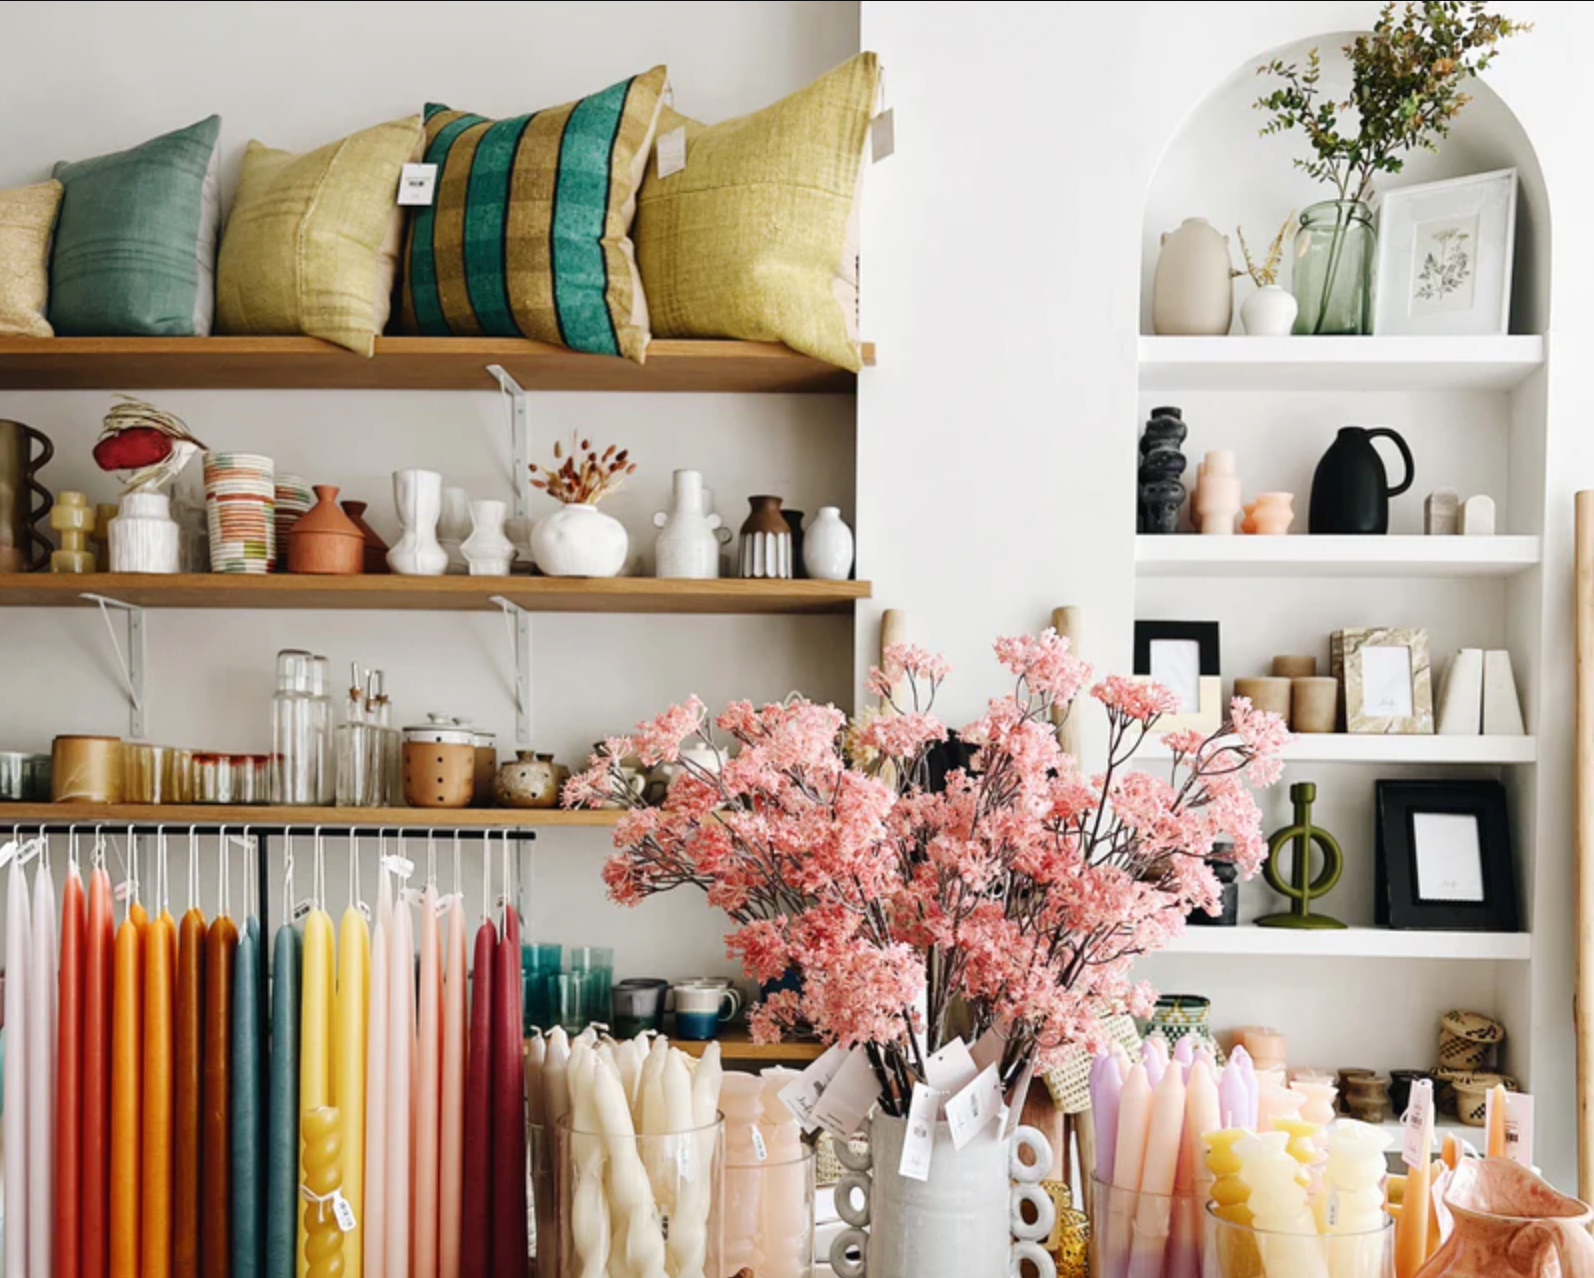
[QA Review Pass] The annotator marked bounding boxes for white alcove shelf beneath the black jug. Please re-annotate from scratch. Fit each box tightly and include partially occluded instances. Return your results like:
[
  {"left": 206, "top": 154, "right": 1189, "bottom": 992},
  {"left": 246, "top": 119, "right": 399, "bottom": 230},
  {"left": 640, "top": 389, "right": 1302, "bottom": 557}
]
[{"left": 1135, "top": 534, "right": 1543, "bottom": 578}]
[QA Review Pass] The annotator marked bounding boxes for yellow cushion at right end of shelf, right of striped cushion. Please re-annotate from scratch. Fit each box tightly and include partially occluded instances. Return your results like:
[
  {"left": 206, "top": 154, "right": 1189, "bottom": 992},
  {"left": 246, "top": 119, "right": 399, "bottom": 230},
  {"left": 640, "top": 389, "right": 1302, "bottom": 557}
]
[{"left": 631, "top": 53, "right": 880, "bottom": 370}]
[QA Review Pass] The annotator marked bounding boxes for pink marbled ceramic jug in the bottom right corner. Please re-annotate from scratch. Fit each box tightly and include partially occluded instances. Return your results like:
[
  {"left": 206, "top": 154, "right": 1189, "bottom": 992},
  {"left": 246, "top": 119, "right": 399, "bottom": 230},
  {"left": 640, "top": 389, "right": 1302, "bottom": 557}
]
[{"left": 1417, "top": 1158, "right": 1594, "bottom": 1278}]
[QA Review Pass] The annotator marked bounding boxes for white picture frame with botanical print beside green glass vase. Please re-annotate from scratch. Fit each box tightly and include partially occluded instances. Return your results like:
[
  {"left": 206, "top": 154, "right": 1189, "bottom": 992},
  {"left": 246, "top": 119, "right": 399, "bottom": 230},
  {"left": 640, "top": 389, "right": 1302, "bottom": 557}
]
[{"left": 1372, "top": 169, "right": 1517, "bottom": 336}]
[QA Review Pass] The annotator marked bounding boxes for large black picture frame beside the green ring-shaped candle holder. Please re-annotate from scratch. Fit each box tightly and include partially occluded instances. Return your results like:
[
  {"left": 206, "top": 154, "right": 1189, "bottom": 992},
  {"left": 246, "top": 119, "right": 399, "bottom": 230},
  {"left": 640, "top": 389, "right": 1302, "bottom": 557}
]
[{"left": 1374, "top": 781, "right": 1522, "bottom": 932}]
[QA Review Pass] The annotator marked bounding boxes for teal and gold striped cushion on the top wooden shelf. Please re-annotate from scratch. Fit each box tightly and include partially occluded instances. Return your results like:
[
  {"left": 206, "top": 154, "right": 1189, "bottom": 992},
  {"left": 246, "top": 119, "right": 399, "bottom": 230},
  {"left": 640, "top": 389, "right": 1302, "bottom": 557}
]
[{"left": 402, "top": 67, "right": 666, "bottom": 363}]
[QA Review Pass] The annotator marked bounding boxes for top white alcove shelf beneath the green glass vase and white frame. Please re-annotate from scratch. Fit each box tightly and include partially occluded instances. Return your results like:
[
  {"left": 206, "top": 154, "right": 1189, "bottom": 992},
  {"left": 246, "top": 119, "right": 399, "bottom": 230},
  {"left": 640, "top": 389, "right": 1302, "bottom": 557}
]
[{"left": 1140, "top": 338, "right": 1545, "bottom": 392}]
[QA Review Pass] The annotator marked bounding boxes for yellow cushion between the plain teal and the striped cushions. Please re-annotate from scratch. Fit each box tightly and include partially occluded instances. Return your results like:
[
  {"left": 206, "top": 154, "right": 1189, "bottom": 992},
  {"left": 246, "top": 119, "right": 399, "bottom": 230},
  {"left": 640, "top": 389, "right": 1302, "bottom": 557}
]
[{"left": 215, "top": 115, "right": 422, "bottom": 355}]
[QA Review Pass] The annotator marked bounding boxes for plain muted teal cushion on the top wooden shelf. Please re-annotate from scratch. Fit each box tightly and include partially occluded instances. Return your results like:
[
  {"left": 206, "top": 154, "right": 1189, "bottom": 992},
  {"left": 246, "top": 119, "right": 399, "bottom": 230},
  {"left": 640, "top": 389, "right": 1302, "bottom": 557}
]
[{"left": 49, "top": 115, "right": 222, "bottom": 338}]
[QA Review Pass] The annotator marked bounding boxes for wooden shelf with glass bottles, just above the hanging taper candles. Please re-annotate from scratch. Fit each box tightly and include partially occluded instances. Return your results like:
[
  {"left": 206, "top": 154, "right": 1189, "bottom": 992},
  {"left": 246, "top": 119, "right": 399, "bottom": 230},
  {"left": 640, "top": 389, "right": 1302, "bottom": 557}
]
[{"left": 0, "top": 803, "right": 620, "bottom": 830}]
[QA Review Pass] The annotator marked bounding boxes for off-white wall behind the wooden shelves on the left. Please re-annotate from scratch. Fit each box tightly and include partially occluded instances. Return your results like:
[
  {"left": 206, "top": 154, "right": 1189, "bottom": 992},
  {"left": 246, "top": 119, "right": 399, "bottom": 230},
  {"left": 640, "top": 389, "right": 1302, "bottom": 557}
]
[{"left": 0, "top": 0, "right": 858, "bottom": 975}]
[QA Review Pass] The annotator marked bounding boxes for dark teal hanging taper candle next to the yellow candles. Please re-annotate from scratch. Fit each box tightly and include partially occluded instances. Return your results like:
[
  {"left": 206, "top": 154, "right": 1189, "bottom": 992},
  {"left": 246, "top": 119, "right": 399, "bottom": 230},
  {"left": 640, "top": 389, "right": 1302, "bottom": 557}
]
[{"left": 266, "top": 923, "right": 300, "bottom": 1278}]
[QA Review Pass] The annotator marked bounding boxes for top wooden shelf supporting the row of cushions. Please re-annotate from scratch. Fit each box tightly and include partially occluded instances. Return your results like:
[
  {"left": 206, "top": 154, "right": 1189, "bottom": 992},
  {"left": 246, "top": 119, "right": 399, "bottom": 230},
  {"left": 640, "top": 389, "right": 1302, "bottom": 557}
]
[{"left": 0, "top": 338, "right": 874, "bottom": 394}]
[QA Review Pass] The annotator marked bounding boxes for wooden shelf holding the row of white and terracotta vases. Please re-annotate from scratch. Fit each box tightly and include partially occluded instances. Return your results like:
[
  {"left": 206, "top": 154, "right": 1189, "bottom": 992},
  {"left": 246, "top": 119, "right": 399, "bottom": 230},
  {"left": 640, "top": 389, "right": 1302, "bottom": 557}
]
[{"left": 0, "top": 572, "right": 869, "bottom": 615}]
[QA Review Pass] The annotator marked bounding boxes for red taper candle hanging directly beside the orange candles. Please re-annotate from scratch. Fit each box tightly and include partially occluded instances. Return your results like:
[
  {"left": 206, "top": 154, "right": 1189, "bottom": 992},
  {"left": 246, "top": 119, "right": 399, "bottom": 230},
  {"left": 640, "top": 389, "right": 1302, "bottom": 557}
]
[{"left": 81, "top": 870, "right": 116, "bottom": 1278}]
